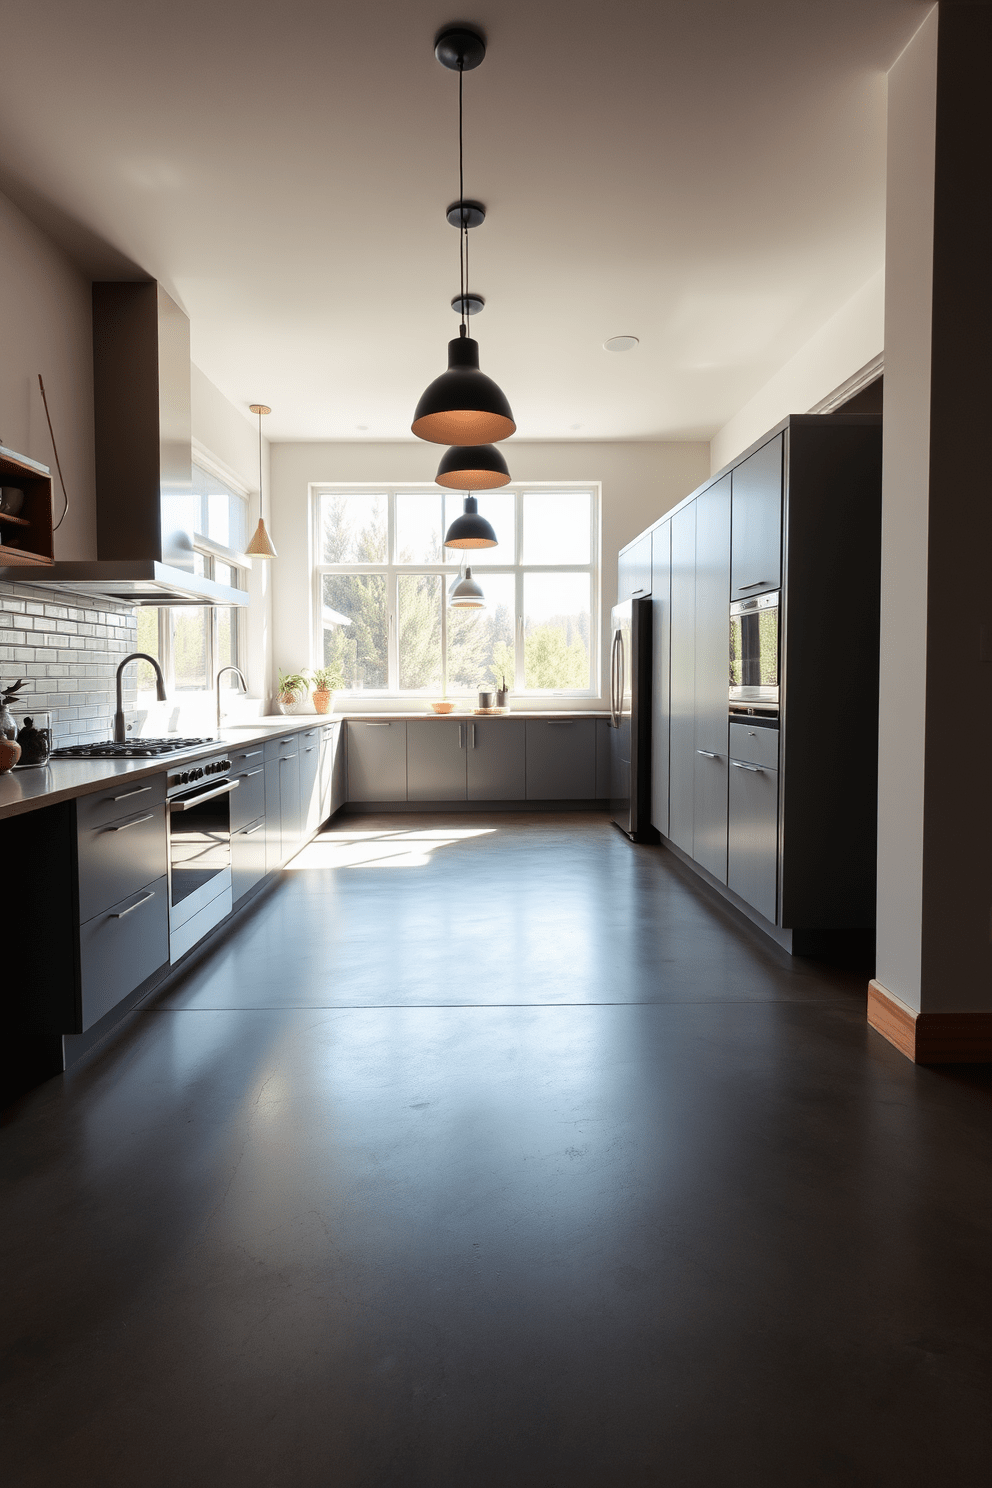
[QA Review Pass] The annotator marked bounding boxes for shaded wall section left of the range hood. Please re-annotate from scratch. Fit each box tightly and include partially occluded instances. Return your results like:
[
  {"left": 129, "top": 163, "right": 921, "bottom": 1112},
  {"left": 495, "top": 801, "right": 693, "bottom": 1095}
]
[{"left": 0, "top": 187, "right": 97, "bottom": 559}]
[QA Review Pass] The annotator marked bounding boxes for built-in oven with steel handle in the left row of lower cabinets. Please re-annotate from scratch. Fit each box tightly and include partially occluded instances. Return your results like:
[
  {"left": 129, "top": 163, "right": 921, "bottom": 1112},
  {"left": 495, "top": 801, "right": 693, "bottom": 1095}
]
[{"left": 168, "top": 754, "right": 238, "bottom": 961}]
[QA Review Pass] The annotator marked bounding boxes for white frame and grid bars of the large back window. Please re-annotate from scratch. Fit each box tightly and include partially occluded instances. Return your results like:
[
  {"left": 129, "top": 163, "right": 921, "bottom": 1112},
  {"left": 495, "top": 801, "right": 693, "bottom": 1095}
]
[{"left": 309, "top": 481, "right": 602, "bottom": 699}]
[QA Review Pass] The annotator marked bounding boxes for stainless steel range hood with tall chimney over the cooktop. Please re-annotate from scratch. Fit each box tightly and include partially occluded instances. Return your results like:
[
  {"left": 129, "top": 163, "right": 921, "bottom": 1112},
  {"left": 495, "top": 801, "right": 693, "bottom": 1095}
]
[{"left": 0, "top": 283, "right": 248, "bottom": 606}]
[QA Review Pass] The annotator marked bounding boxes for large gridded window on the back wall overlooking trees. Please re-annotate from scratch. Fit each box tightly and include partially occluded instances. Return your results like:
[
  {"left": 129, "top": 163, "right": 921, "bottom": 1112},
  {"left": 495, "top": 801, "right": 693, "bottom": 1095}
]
[{"left": 314, "top": 485, "right": 599, "bottom": 695}]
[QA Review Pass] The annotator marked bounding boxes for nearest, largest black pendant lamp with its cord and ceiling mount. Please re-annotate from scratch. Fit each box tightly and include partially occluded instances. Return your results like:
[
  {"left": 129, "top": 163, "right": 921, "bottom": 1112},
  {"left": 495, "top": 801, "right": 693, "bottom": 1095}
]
[{"left": 410, "top": 27, "right": 516, "bottom": 446}]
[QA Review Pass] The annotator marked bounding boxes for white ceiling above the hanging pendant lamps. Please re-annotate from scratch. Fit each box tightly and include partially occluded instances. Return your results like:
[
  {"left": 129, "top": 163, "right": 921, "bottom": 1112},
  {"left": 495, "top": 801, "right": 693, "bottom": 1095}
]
[{"left": 0, "top": 0, "right": 930, "bottom": 439}]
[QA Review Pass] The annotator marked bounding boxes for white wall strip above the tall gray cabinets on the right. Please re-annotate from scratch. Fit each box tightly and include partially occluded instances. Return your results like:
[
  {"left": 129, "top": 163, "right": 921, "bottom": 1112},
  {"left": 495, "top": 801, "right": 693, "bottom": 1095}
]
[{"left": 709, "top": 269, "right": 885, "bottom": 472}]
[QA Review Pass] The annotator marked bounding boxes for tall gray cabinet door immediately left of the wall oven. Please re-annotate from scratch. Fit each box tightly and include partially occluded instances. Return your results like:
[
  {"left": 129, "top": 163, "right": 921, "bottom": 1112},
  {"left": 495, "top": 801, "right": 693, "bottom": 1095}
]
[{"left": 692, "top": 475, "right": 730, "bottom": 884}]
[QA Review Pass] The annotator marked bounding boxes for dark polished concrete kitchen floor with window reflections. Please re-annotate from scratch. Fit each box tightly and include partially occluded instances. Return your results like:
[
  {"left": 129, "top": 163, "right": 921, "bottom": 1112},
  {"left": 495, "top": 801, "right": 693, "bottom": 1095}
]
[{"left": 0, "top": 814, "right": 992, "bottom": 1488}]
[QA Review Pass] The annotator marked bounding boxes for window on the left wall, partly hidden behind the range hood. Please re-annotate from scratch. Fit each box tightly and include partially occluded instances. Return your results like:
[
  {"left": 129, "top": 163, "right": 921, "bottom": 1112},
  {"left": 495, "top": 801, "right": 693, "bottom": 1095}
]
[{"left": 137, "top": 464, "right": 248, "bottom": 693}]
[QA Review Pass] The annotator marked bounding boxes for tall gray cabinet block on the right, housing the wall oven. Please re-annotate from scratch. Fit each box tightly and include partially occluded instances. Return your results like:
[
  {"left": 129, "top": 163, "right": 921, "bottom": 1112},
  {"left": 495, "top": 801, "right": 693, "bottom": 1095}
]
[{"left": 622, "top": 414, "right": 882, "bottom": 951}]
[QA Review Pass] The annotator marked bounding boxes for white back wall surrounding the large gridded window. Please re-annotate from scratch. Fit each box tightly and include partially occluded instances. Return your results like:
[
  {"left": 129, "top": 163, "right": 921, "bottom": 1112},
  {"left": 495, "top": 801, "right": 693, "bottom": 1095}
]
[{"left": 272, "top": 439, "right": 709, "bottom": 707}]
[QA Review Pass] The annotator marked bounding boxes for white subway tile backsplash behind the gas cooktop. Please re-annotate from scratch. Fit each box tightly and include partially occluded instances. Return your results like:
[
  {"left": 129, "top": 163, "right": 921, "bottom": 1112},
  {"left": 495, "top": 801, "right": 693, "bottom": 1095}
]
[{"left": 0, "top": 583, "right": 138, "bottom": 744}]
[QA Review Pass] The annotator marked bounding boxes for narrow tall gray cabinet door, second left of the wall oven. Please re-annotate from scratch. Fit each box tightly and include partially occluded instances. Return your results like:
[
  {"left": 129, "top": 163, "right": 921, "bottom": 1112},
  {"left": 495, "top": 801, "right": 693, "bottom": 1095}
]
[{"left": 668, "top": 501, "right": 696, "bottom": 856}]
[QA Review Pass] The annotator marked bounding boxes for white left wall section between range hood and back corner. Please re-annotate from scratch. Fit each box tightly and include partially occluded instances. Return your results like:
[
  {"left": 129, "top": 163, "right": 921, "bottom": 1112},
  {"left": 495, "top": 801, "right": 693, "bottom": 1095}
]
[{"left": 190, "top": 366, "right": 272, "bottom": 698}]
